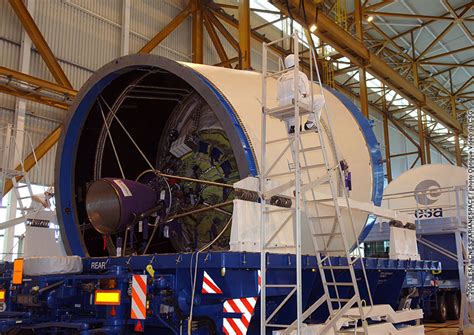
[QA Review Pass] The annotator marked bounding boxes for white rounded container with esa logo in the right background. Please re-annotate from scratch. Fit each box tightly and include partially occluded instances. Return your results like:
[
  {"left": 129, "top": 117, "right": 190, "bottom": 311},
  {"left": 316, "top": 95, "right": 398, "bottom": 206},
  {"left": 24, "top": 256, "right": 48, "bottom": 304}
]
[{"left": 366, "top": 164, "right": 467, "bottom": 242}]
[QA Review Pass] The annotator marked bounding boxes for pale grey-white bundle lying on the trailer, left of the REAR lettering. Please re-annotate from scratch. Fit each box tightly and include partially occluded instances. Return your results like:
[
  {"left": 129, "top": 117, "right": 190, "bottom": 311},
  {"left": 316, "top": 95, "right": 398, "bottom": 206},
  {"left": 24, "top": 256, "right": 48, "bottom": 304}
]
[{"left": 23, "top": 256, "right": 82, "bottom": 276}]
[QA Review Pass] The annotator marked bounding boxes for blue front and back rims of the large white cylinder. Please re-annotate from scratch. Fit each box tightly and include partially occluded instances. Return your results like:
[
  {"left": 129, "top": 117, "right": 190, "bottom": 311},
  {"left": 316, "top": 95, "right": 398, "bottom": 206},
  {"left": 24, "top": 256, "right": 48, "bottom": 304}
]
[{"left": 55, "top": 55, "right": 383, "bottom": 257}]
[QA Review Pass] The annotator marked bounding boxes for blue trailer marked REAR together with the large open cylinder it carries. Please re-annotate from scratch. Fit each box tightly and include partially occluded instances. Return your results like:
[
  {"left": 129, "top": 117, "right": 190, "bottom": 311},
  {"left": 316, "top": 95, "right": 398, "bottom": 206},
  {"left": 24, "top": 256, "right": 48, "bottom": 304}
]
[{"left": 0, "top": 55, "right": 441, "bottom": 334}]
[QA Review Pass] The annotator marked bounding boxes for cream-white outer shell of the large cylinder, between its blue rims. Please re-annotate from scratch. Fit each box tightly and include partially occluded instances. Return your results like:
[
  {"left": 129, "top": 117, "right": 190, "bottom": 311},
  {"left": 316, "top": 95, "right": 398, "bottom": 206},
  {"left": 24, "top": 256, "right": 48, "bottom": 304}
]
[{"left": 184, "top": 63, "right": 373, "bottom": 249}]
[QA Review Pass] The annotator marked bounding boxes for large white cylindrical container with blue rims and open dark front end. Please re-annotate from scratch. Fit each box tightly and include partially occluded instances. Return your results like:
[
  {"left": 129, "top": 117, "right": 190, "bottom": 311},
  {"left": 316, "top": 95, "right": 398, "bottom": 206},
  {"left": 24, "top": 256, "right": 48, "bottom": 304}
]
[{"left": 56, "top": 55, "right": 383, "bottom": 256}]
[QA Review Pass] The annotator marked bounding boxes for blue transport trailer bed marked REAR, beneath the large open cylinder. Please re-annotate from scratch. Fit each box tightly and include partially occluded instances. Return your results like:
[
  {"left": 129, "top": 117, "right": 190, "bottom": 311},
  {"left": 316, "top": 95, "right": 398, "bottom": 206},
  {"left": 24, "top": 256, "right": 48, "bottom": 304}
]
[{"left": 0, "top": 252, "right": 440, "bottom": 334}]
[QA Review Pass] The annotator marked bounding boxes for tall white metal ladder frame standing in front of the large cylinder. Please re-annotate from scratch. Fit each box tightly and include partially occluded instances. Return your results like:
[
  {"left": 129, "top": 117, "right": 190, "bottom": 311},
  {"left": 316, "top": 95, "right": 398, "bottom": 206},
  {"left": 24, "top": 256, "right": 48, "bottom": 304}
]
[{"left": 259, "top": 32, "right": 372, "bottom": 334}]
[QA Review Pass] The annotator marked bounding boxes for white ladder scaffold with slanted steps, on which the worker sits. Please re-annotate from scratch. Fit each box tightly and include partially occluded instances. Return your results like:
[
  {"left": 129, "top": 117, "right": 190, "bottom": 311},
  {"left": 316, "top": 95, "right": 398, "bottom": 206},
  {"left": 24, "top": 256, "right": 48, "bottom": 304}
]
[{"left": 260, "top": 31, "right": 373, "bottom": 335}]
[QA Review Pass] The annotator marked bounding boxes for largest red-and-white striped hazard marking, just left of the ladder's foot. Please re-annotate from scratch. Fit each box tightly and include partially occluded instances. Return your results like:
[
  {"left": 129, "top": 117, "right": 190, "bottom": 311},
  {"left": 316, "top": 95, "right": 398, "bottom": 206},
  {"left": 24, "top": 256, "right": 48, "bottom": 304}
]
[{"left": 223, "top": 297, "right": 257, "bottom": 335}]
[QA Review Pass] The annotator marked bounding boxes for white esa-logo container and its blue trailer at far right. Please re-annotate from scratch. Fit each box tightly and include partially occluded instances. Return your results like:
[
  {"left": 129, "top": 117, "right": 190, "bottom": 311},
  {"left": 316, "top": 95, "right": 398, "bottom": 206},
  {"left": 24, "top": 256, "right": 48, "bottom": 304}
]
[{"left": 365, "top": 164, "right": 469, "bottom": 330}]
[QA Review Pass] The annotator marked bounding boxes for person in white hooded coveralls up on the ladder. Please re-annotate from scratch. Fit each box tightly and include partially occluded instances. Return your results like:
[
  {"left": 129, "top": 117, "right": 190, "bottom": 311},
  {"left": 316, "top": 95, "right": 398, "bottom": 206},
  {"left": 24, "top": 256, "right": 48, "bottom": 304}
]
[{"left": 278, "top": 54, "right": 324, "bottom": 134}]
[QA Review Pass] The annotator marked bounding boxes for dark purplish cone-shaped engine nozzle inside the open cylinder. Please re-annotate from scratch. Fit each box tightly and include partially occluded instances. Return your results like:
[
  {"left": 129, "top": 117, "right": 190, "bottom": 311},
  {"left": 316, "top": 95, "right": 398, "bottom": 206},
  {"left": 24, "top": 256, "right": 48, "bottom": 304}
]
[{"left": 86, "top": 178, "right": 157, "bottom": 234}]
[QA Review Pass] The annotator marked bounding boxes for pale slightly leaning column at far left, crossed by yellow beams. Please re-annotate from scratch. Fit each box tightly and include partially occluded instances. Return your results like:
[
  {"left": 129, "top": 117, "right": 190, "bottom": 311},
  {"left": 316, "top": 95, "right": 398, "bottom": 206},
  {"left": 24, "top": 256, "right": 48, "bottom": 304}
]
[{"left": 3, "top": 0, "right": 35, "bottom": 261}]
